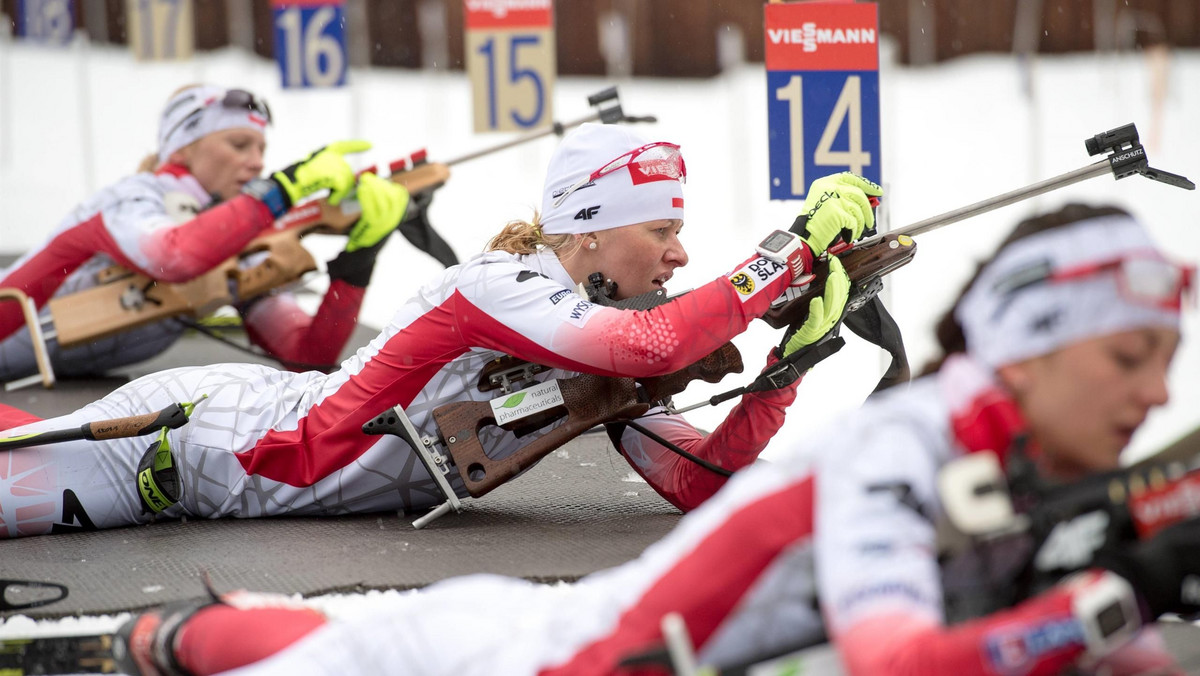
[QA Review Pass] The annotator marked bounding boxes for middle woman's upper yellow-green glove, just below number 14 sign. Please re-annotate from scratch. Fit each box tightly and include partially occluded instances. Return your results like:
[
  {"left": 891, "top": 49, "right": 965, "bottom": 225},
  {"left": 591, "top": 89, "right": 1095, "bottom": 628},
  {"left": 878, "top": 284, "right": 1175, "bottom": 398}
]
[{"left": 792, "top": 172, "right": 883, "bottom": 256}]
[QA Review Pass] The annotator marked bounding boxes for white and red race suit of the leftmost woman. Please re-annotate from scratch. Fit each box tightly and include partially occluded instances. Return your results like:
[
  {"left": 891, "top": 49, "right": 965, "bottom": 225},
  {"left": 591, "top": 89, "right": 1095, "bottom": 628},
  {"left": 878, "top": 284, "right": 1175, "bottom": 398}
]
[{"left": 0, "top": 164, "right": 364, "bottom": 381}]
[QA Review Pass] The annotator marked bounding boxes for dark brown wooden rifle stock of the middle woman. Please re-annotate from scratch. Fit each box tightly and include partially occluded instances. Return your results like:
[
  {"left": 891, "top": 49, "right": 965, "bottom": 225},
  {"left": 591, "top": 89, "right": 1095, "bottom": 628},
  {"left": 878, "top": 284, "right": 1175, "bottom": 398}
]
[{"left": 433, "top": 342, "right": 743, "bottom": 497}]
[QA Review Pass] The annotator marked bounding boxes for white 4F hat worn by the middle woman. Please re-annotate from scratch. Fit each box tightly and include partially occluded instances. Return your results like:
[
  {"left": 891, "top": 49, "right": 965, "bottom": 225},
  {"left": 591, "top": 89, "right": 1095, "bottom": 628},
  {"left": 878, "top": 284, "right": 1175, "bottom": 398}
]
[{"left": 541, "top": 122, "right": 683, "bottom": 234}]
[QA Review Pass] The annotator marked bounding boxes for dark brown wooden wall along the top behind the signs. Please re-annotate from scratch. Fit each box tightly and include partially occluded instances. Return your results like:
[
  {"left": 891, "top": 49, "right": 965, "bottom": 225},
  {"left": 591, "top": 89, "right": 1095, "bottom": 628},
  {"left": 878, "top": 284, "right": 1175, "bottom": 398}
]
[{"left": 0, "top": 0, "right": 1200, "bottom": 77}]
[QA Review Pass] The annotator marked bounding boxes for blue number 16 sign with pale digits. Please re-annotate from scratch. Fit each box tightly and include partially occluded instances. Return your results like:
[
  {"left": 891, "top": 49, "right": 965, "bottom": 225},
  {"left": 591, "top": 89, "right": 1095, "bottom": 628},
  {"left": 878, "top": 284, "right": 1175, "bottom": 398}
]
[{"left": 271, "top": 0, "right": 348, "bottom": 88}]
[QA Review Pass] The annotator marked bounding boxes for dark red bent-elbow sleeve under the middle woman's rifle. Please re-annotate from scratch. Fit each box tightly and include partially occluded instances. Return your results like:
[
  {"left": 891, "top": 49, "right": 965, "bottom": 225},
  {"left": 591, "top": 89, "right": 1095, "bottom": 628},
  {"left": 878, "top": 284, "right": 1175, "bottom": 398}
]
[{"left": 617, "top": 351, "right": 799, "bottom": 512}]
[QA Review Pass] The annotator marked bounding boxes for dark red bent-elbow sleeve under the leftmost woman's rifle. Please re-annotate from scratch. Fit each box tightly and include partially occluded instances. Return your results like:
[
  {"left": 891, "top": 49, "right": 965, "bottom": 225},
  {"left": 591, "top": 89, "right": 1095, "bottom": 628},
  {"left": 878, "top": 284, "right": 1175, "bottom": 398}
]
[{"left": 244, "top": 280, "right": 366, "bottom": 370}]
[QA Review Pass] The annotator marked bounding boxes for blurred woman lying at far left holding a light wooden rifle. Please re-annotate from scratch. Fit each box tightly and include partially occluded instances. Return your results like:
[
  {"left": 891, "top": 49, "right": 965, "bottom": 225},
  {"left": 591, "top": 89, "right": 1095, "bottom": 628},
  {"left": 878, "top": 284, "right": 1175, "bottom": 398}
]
[{"left": 0, "top": 85, "right": 409, "bottom": 381}]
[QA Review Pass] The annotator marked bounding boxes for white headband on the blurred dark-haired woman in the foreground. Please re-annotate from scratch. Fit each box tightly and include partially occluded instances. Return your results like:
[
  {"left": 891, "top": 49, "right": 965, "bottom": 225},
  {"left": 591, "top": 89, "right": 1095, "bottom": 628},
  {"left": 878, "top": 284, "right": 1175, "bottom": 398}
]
[{"left": 954, "top": 215, "right": 1180, "bottom": 369}]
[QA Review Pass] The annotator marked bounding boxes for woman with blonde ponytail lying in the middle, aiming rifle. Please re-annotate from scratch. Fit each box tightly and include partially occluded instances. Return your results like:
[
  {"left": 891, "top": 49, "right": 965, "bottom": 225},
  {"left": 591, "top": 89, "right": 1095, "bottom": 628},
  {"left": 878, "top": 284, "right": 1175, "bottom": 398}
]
[{"left": 0, "top": 120, "right": 880, "bottom": 537}]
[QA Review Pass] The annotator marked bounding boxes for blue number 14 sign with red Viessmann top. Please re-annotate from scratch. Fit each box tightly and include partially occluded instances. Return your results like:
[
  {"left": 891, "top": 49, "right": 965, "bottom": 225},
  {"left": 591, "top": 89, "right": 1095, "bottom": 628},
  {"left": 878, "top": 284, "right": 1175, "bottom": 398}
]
[{"left": 764, "top": 2, "right": 882, "bottom": 199}]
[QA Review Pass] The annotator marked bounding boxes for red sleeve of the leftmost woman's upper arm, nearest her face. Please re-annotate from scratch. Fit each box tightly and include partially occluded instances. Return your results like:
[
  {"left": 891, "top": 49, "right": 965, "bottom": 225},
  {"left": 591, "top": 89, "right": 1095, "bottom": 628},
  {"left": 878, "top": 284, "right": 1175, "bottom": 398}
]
[{"left": 142, "top": 195, "right": 275, "bottom": 282}]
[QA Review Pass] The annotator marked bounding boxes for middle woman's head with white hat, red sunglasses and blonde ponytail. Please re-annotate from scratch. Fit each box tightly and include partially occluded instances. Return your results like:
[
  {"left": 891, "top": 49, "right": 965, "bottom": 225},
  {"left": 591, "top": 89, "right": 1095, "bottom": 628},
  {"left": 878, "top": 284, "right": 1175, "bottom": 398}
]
[{"left": 488, "top": 124, "right": 688, "bottom": 298}]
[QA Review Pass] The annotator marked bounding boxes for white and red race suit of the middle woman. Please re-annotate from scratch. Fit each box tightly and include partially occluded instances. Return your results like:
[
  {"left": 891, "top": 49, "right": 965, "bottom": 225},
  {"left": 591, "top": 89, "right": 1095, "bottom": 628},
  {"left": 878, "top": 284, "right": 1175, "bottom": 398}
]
[{"left": 0, "top": 246, "right": 796, "bottom": 537}]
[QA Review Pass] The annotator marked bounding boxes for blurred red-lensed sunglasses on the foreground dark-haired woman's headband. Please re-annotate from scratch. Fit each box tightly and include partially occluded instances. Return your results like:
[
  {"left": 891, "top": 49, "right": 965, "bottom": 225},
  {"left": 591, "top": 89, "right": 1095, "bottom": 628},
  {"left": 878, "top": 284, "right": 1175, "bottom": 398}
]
[{"left": 996, "top": 251, "right": 1195, "bottom": 311}]
